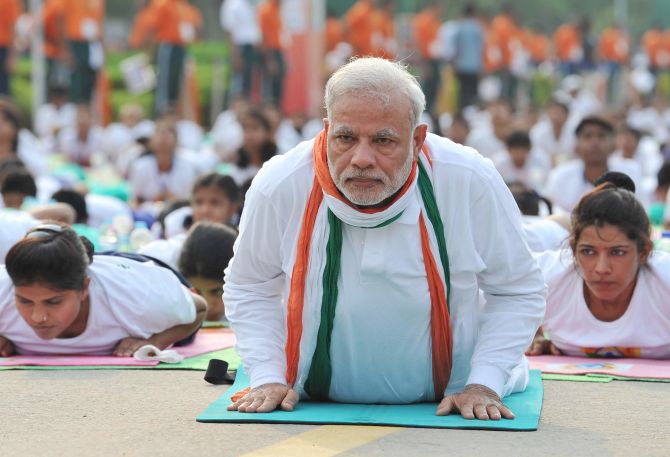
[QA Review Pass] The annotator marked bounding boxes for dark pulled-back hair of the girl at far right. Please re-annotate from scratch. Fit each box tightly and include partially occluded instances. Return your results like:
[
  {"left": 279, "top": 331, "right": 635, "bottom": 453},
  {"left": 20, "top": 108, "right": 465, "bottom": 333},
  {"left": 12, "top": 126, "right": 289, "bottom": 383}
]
[{"left": 570, "top": 182, "right": 651, "bottom": 252}]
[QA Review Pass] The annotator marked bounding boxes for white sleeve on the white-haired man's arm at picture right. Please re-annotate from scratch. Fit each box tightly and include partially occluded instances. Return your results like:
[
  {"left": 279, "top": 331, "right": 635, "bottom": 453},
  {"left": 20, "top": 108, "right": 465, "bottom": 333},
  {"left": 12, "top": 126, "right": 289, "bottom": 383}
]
[{"left": 467, "top": 167, "right": 546, "bottom": 396}]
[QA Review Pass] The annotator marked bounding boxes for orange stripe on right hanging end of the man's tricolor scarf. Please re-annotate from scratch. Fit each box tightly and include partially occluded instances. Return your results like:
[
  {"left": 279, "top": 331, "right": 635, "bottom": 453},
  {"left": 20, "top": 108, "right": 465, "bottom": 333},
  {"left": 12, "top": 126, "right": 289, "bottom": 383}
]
[{"left": 419, "top": 216, "right": 453, "bottom": 401}]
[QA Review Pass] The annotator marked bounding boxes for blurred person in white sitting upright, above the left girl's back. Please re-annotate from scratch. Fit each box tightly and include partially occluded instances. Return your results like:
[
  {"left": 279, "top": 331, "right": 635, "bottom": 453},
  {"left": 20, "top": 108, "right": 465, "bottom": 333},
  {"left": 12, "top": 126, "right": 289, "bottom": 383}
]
[{"left": 128, "top": 118, "right": 198, "bottom": 202}]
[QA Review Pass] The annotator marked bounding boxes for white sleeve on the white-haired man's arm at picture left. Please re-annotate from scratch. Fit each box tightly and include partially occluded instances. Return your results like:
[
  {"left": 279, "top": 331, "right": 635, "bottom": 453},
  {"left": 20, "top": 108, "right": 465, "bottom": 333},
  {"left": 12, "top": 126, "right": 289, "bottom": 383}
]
[{"left": 223, "top": 180, "right": 286, "bottom": 388}]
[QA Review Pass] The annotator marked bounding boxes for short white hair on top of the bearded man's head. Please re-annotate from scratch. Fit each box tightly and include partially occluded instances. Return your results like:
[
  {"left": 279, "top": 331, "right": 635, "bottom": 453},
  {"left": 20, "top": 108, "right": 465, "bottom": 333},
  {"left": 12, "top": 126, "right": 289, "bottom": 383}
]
[{"left": 324, "top": 57, "right": 426, "bottom": 128}]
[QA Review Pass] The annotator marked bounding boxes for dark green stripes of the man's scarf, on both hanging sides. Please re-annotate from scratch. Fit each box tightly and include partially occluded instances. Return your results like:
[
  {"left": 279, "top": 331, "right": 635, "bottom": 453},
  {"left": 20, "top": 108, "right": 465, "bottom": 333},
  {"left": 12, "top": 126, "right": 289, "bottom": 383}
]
[{"left": 305, "top": 160, "right": 451, "bottom": 401}]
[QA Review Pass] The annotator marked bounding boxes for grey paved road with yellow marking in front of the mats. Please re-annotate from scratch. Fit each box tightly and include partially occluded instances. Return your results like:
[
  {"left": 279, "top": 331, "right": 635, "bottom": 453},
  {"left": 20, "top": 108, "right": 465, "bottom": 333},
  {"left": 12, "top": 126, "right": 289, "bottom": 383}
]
[{"left": 0, "top": 370, "right": 670, "bottom": 457}]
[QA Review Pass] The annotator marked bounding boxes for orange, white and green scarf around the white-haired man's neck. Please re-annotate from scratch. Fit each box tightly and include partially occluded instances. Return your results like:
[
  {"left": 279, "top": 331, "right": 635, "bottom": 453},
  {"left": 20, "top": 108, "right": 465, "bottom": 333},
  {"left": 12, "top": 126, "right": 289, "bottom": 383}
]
[{"left": 286, "top": 131, "right": 452, "bottom": 400}]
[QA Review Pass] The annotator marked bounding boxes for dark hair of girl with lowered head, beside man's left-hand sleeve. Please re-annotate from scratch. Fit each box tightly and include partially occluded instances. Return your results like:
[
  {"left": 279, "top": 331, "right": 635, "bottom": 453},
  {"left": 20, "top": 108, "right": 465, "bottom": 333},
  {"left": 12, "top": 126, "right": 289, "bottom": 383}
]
[{"left": 178, "top": 222, "right": 237, "bottom": 279}]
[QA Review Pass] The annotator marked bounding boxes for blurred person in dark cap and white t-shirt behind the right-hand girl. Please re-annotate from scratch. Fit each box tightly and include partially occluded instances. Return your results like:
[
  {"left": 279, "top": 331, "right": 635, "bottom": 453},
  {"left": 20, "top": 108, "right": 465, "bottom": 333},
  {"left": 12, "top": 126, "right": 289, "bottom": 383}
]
[{"left": 544, "top": 116, "right": 640, "bottom": 212}]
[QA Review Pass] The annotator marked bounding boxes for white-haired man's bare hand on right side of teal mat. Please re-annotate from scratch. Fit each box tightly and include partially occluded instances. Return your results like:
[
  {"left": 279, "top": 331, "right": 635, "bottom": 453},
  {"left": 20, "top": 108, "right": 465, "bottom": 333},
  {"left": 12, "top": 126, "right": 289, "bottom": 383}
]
[{"left": 435, "top": 384, "right": 514, "bottom": 420}]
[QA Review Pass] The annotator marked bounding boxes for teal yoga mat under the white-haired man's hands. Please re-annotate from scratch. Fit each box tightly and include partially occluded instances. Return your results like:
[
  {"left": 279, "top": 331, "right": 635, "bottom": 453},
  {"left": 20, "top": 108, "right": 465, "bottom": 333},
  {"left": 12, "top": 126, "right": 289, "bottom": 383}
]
[{"left": 197, "top": 369, "right": 544, "bottom": 431}]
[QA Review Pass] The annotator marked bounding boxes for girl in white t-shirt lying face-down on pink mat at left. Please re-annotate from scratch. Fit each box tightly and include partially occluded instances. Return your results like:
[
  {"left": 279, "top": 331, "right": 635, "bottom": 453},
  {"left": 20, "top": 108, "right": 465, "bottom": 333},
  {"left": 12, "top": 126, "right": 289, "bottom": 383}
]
[{"left": 0, "top": 224, "right": 207, "bottom": 357}]
